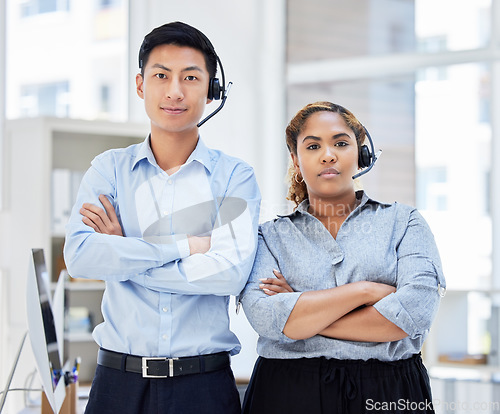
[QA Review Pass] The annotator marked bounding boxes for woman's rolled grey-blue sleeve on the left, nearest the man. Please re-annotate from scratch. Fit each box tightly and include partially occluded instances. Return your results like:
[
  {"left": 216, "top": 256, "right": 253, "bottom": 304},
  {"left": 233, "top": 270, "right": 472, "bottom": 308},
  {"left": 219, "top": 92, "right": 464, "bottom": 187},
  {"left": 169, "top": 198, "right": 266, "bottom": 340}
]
[{"left": 240, "top": 226, "right": 301, "bottom": 343}]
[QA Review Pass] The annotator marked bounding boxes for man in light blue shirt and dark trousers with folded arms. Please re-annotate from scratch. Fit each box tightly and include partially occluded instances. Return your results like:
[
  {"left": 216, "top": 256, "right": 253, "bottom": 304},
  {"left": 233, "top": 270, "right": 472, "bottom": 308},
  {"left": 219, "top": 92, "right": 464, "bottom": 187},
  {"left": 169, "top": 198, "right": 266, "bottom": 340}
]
[{"left": 64, "top": 22, "right": 260, "bottom": 414}]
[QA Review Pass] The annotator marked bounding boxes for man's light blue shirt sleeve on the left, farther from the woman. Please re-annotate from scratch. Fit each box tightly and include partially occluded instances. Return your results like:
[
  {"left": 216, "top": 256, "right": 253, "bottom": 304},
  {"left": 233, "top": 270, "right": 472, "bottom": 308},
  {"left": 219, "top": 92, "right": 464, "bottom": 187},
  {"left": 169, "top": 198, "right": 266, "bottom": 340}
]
[{"left": 64, "top": 151, "right": 189, "bottom": 281}]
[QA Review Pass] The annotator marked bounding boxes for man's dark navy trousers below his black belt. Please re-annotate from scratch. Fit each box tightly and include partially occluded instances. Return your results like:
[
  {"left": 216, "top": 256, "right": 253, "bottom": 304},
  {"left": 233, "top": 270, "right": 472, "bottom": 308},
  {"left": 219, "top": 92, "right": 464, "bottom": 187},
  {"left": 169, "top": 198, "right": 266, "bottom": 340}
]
[{"left": 85, "top": 365, "right": 241, "bottom": 414}]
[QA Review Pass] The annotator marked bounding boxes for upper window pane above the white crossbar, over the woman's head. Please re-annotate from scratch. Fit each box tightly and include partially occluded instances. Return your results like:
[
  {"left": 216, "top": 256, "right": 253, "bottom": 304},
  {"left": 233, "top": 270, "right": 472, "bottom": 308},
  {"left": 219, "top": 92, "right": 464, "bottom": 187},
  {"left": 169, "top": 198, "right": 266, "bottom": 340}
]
[{"left": 287, "top": 0, "right": 491, "bottom": 62}]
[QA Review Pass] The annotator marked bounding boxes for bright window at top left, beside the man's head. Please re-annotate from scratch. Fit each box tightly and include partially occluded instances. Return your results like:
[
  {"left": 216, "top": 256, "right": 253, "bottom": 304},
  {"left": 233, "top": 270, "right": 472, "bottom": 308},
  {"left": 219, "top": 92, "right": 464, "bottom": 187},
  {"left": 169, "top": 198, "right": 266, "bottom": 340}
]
[{"left": 6, "top": 0, "right": 130, "bottom": 121}]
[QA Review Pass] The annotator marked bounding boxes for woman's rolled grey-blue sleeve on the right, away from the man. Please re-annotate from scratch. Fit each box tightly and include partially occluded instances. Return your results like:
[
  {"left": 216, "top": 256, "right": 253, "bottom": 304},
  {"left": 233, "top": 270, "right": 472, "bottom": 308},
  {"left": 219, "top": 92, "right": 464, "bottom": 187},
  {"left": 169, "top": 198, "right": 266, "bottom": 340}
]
[{"left": 374, "top": 209, "right": 445, "bottom": 339}]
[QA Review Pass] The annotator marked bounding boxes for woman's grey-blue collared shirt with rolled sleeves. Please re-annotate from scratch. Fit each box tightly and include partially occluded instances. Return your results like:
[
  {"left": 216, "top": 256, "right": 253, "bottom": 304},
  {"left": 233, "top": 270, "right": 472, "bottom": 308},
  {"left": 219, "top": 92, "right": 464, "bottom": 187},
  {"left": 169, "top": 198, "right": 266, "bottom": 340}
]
[{"left": 241, "top": 192, "right": 445, "bottom": 361}]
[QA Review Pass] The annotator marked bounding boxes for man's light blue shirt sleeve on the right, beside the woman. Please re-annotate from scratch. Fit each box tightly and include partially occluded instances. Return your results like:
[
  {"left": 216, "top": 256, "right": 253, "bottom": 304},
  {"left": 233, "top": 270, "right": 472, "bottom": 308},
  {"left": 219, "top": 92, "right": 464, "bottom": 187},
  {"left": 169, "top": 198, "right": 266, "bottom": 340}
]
[{"left": 141, "top": 163, "right": 260, "bottom": 296}]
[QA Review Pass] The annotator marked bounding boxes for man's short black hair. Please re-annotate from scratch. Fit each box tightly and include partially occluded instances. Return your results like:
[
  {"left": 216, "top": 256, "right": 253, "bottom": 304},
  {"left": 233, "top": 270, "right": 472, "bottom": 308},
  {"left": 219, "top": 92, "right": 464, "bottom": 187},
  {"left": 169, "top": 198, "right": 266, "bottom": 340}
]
[{"left": 139, "top": 22, "right": 217, "bottom": 78}]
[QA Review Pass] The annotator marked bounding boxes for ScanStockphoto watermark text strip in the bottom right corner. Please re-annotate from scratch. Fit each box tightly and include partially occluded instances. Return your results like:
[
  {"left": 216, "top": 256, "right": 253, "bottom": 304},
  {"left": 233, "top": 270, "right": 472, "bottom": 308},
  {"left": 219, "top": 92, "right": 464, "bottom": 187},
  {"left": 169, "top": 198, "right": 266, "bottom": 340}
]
[{"left": 365, "top": 398, "right": 500, "bottom": 413}]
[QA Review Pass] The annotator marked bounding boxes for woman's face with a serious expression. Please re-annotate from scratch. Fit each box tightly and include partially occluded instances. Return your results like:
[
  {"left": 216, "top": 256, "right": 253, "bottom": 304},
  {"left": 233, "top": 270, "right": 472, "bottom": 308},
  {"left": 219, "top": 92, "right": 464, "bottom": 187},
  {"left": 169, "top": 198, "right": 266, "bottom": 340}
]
[{"left": 291, "top": 111, "right": 358, "bottom": 201}]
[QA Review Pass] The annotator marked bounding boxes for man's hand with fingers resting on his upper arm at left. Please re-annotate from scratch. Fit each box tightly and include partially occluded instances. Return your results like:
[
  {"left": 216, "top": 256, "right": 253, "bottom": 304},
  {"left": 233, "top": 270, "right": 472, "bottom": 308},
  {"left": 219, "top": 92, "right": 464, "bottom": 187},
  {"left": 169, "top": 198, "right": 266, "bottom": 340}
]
[{"left": 80, "top": 194, "right": 123, "bottom": 236}]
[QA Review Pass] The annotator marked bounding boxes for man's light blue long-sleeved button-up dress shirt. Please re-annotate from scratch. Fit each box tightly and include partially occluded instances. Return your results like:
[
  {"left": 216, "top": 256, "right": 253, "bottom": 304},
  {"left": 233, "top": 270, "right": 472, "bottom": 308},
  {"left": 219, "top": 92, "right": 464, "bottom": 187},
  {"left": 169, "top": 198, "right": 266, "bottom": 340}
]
[{"left": 64, "top": 138, "right": 260, "bottom": 357}]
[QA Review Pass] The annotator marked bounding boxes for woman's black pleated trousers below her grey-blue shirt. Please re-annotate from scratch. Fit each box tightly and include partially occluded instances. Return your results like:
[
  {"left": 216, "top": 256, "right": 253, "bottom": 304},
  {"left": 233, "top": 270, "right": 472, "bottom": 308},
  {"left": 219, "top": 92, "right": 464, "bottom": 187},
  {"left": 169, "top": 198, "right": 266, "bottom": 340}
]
[{"left": 243, "top": 355, "right": 434, "bottom": 414}]
